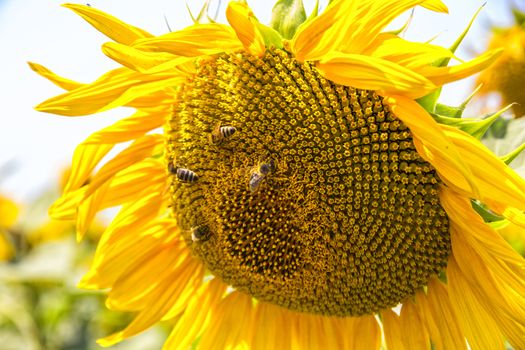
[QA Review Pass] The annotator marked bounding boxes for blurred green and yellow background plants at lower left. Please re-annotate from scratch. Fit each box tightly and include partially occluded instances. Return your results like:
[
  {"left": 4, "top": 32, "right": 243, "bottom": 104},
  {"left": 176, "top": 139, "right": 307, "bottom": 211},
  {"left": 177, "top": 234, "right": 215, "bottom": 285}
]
[{"left": 0, "top": 179, "right": 166, "bottom": 350}]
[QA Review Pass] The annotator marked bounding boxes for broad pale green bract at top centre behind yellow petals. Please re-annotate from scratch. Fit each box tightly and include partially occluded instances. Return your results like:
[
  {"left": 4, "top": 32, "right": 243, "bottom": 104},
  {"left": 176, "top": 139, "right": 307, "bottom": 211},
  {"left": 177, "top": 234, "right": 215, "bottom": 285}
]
[{"left": 270, "top": 0, "right": 306, "bottom": 39}]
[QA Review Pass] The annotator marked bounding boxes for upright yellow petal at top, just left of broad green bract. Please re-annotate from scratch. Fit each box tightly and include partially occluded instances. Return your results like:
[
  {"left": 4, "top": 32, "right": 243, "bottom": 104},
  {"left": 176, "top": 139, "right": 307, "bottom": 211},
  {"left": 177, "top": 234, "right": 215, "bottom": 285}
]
[{"left": 226, "top": 1, "right": 265, "bottom": 57}]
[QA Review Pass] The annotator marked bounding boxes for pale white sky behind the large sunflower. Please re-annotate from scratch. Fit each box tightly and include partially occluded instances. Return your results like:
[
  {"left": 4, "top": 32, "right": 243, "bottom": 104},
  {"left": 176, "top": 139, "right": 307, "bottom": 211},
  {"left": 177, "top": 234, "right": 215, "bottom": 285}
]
[{"left": 0, "top": 0, "right": 525, "bottom": 201}]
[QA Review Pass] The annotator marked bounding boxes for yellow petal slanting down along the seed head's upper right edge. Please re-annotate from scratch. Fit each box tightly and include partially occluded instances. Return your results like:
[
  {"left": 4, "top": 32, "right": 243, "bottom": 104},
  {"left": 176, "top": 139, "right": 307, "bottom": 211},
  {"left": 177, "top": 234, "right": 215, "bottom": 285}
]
[{"left": 386, "top": 96, "right": 478, "bottom": 194}]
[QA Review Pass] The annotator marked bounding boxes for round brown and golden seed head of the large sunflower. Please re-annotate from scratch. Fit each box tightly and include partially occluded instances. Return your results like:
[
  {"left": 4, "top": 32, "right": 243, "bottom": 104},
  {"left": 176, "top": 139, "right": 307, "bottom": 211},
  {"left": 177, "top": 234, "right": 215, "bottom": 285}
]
[{"left": 166, "top": 50, "right": 450, "bottom": 316}]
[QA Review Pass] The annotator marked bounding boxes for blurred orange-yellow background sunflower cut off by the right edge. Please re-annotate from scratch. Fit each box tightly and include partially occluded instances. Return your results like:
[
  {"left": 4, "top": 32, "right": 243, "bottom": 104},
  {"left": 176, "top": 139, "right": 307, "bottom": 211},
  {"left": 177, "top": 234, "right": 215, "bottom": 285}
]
[{"left": 477, "top": 10, "right": 525, "bottom": 117}]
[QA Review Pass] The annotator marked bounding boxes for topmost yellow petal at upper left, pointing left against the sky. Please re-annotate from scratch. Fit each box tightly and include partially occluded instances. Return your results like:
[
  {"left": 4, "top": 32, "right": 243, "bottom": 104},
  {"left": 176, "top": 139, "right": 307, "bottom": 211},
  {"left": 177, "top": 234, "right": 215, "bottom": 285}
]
[{"left": 62, "top": 4, "right": 152, "bottom": 45}]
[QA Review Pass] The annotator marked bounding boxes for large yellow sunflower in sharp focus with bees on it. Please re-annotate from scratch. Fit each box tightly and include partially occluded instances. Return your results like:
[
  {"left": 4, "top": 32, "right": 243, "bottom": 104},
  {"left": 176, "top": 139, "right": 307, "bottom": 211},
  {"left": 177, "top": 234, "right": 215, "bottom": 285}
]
[{"left": 31, "top": 0, "right": 525, "bottom": 349}]
